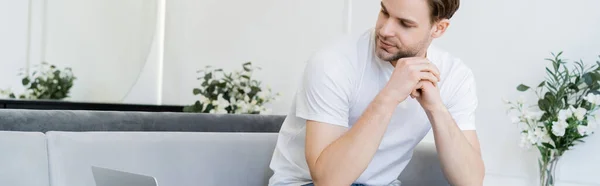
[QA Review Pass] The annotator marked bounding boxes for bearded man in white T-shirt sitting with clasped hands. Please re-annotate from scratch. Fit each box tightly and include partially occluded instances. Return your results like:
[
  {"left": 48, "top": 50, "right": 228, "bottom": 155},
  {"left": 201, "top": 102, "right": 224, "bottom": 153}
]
[{"left": 269, "top": 0, "right": 484, "bottom": 186}]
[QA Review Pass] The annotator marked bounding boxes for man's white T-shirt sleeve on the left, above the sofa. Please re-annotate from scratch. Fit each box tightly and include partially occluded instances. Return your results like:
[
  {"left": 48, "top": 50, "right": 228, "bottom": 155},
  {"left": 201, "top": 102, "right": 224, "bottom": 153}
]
[{"left": 296, "top": 51, "right": 355, "bottom": 127}]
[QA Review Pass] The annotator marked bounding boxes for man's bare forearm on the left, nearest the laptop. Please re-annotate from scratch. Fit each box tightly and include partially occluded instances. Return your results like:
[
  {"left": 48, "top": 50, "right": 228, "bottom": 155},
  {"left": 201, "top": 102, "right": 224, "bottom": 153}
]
[{"left": 311, "top": 93, "right": 397, "bottom": 185}]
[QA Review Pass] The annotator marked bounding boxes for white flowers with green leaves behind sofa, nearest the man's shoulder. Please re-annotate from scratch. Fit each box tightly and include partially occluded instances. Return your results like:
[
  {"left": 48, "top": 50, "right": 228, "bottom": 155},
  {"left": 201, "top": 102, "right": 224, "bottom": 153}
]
[{"left": 184, "top": 62, "right": 279, "bottom": 114}]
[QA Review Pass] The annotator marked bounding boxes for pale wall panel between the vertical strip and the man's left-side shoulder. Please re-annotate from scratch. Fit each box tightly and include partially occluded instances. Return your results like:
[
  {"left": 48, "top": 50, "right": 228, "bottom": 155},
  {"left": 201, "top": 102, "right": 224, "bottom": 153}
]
[{"left": 163, "top": 0, "right": 346, "bottom": 114}]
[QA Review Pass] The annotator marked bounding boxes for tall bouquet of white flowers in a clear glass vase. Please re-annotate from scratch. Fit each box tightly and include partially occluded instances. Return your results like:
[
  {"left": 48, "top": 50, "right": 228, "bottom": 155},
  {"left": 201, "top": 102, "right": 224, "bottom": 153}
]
[{"left": 505, "top": 52, "right": 600, "bottom": 186}]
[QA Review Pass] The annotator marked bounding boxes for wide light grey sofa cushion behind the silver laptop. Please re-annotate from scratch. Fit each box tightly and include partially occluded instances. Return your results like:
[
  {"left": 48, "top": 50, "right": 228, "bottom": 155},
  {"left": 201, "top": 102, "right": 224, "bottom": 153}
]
[{"left": 47, "top": 131, "right": 277, "bottom": 186}]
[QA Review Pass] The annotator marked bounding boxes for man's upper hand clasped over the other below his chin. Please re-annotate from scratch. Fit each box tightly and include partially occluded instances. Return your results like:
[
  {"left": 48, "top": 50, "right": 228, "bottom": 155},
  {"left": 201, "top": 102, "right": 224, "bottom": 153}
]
[{"left": 383, "top": 57, "right": 440, "bottom": 103}]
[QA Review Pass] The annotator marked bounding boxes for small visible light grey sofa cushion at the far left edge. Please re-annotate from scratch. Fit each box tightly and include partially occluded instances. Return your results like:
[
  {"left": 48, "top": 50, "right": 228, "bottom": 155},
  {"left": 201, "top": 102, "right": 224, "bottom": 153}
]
[{"left": 0, "top": 131, "right": 50, "bottom": 186}]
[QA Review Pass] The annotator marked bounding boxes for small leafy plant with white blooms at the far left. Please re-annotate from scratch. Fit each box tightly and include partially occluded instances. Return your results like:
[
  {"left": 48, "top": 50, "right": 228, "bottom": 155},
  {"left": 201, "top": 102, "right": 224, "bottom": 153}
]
[{"left": 0, "top": 62, "right": 77, "bottom": 100}]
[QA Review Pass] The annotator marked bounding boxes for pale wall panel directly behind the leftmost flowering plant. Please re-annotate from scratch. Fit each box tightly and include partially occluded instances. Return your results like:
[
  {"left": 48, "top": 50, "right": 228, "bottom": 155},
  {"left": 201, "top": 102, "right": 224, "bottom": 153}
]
[{"left": 43, "top": 0, "right": 157, "bottom": 102}]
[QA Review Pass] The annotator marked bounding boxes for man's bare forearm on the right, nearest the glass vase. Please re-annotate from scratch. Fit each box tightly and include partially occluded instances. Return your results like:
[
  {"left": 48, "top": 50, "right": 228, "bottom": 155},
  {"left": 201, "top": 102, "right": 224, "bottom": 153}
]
[{"left": 426, "top": 106, "right": 485, "bottom": 186}]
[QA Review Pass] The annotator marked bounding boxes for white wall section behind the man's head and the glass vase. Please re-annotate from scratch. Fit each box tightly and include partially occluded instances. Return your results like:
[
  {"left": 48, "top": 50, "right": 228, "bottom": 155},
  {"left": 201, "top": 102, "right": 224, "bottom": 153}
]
[{"left": 352, "top": 0, "right": 600, "bottom": 185}]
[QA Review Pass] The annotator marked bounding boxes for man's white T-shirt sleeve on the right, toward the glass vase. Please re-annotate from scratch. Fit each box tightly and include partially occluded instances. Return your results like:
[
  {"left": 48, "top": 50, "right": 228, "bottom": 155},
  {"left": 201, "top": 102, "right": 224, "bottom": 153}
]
[{"left": 447, "top": 69, "right": 478, "bottom": 130}]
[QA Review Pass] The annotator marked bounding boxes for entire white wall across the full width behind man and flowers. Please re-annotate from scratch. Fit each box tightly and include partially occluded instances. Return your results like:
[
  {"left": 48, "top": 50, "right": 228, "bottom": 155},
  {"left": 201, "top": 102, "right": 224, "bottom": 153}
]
[{"left": 0, "top": 0, "right": 600, "bottom": 186}]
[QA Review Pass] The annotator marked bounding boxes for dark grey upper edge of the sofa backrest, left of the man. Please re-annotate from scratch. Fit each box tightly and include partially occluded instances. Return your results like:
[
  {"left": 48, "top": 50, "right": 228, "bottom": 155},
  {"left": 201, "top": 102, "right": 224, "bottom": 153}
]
[{"left": 0, "top": 109, "right": 285, "bottom": 133}]
